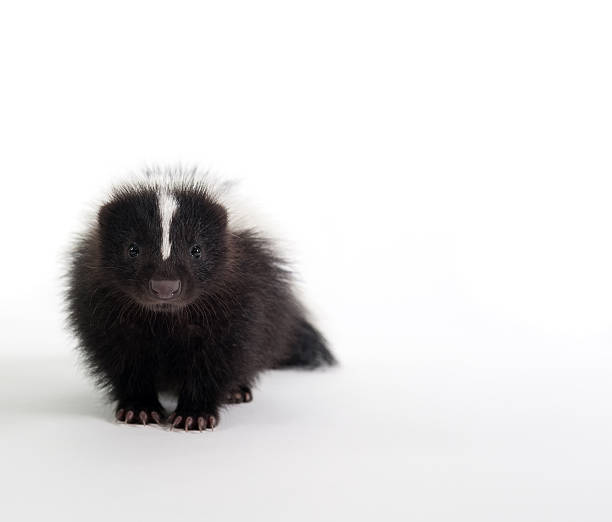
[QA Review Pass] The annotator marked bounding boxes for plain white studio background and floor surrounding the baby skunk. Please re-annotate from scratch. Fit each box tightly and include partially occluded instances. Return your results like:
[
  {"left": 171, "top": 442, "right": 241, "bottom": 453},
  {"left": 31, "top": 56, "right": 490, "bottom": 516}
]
[{"left": 0, "top": 0, "right": 612, "bottom": 522}]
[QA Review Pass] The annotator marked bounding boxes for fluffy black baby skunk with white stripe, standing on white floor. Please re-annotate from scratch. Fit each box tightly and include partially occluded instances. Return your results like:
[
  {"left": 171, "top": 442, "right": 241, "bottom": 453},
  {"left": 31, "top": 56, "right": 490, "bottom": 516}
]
[{"left": 67, "top": 172, "right": 335, "bottom": 431}]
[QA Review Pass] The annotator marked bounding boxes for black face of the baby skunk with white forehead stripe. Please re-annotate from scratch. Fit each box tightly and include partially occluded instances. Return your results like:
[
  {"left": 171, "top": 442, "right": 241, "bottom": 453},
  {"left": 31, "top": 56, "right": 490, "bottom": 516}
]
[{"left": 98, "top": 189, "right": 227, "bottom": 310}]
